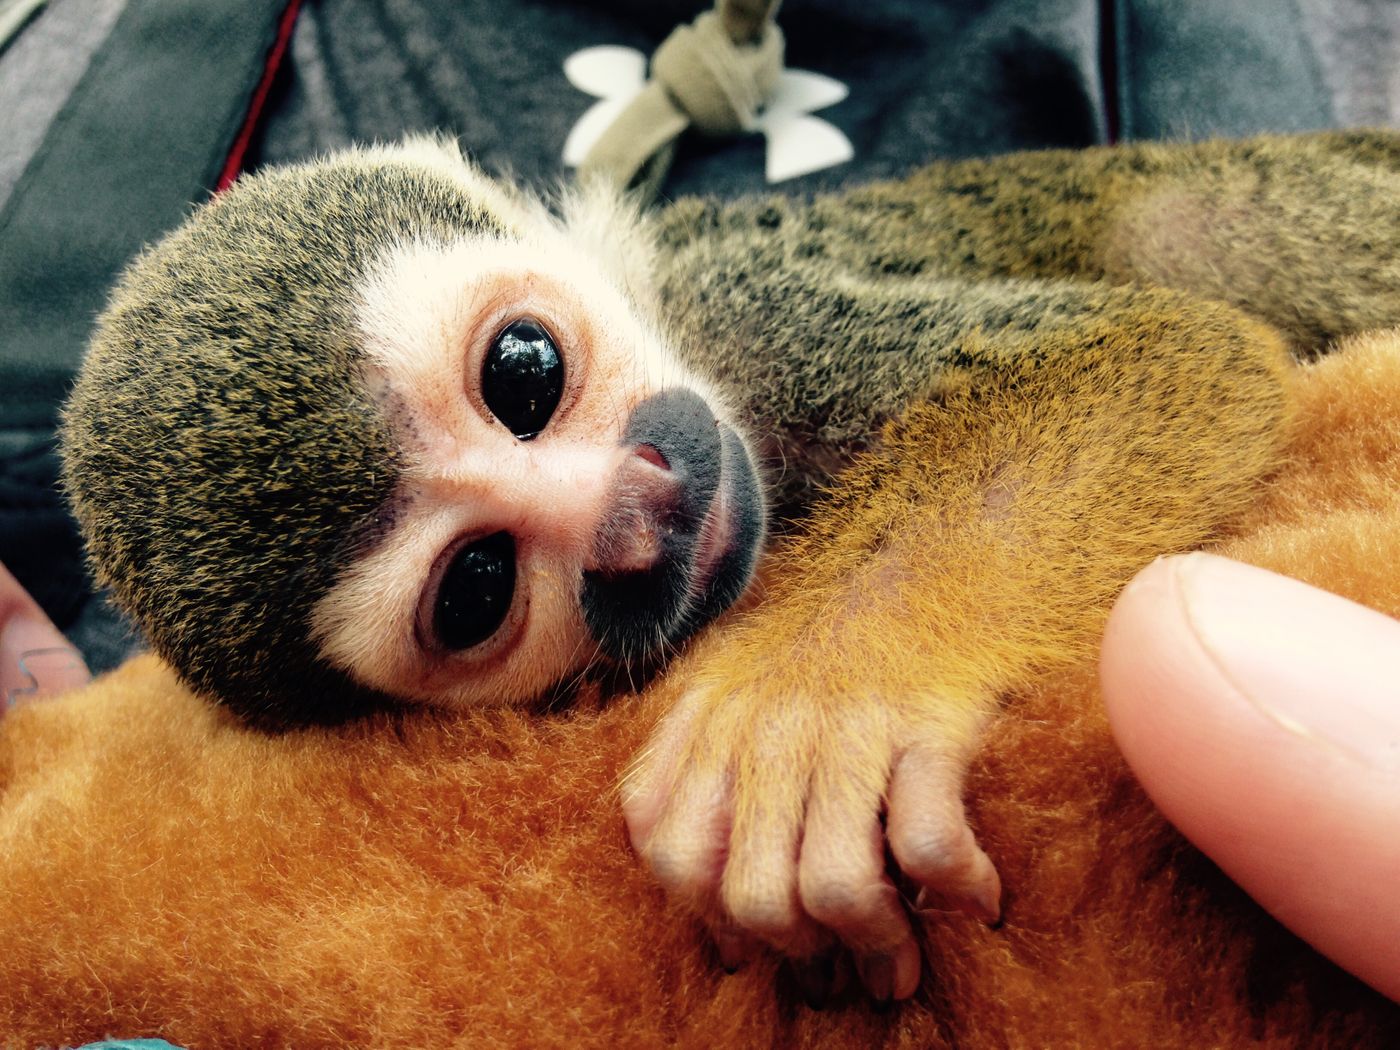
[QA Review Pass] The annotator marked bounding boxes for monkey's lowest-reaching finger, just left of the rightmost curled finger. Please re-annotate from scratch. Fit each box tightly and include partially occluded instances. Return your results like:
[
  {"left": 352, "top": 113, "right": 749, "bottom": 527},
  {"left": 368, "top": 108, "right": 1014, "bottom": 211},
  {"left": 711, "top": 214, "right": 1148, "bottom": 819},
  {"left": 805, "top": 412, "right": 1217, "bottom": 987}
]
[{"left": 798, "top": 763, "right": 920, "bottom": 1002}]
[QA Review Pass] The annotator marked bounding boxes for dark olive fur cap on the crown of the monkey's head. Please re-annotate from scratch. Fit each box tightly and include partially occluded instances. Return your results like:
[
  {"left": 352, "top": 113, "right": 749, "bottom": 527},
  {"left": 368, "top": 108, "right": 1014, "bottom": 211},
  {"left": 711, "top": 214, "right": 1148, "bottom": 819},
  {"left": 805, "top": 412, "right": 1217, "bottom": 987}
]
[{"left": 62, "top": 151, "right": 500, "bottom": 724}]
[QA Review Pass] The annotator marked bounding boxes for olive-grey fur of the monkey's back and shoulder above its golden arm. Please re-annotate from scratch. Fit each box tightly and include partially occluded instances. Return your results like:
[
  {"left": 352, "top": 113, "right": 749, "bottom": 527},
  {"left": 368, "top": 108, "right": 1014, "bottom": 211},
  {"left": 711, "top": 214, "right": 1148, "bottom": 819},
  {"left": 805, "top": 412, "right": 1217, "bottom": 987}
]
[{"left": 654, "top": 132, "right": 1400, "bottom": 511}]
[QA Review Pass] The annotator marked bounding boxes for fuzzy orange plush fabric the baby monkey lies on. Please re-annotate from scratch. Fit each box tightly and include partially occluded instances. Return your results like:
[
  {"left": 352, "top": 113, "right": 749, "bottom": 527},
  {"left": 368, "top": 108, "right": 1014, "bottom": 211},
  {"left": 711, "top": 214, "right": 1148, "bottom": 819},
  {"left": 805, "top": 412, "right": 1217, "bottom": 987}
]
[{"left": 0, "top": 335, "right": 1400, "bottom": 1050}]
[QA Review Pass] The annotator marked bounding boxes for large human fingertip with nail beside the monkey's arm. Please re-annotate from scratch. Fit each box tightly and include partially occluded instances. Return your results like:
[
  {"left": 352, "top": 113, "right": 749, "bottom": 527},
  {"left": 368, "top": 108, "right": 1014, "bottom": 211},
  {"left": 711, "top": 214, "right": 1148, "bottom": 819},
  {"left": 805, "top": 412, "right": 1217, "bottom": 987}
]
[{"left": 1102, "top": 554, "right": 1400, "bottom": 998}]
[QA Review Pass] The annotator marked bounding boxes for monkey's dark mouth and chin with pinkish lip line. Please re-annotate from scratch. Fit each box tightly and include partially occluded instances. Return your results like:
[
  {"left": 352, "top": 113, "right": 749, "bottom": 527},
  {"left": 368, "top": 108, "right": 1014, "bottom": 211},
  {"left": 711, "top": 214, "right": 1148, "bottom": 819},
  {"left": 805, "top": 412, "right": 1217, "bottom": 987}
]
[{"left": 581, "top": 423, "right": 766, "bottom": 666}]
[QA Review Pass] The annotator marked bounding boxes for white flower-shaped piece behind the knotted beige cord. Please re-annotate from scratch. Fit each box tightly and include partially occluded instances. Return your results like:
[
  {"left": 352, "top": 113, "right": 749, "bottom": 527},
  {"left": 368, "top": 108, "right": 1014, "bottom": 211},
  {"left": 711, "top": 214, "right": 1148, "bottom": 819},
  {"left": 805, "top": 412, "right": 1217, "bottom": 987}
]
[{"left": 564, "top": 45, "right": 855, "bottom": 182}]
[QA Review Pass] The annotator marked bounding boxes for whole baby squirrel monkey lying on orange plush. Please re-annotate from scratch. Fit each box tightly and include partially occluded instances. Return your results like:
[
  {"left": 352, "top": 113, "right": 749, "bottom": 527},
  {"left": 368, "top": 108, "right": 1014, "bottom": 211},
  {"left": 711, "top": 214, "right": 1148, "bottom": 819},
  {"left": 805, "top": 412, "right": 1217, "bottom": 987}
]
[{"left": 63, "top": 133, "right": 1400, "bottom": 1000}]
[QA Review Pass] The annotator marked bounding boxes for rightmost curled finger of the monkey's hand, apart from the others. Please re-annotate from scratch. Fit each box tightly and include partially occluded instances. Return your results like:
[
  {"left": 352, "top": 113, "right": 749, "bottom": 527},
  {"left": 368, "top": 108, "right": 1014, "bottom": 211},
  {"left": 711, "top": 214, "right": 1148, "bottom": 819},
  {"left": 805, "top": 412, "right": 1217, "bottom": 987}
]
[{"left": 885, "top": 742, "right": 1001, "bottom": 923}]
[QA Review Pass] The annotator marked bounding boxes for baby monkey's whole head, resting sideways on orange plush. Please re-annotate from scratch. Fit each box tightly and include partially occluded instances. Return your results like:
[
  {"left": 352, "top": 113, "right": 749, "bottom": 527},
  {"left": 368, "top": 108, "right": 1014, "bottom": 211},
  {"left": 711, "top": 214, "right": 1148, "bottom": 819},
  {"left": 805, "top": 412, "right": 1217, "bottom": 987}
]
[{"left": 63, "top": 140, "right": 764, "bottom": 724}]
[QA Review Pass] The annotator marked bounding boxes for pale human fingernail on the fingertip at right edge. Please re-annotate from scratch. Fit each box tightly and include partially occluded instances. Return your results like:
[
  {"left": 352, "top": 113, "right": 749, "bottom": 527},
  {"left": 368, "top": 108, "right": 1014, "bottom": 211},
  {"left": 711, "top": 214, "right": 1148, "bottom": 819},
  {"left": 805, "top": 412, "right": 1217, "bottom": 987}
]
[{"left": 1173, "top": 554, "right": 1400, "bottom": 771}]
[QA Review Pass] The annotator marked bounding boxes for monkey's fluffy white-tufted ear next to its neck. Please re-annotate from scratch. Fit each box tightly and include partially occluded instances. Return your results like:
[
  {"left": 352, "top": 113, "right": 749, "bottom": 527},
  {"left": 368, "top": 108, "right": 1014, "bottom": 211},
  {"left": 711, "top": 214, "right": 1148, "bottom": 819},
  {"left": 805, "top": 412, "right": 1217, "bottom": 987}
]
[{"left": 559, "top": 175, "right": 657, "bottom": 309}]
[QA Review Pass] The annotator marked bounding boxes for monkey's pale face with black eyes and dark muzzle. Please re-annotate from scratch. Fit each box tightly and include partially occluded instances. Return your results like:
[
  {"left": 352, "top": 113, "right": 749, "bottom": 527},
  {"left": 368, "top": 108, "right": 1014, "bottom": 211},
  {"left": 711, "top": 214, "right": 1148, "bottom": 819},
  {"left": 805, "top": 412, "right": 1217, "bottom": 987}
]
[{"left": 312, "top": 224, "right": 763, "bottom": 704}]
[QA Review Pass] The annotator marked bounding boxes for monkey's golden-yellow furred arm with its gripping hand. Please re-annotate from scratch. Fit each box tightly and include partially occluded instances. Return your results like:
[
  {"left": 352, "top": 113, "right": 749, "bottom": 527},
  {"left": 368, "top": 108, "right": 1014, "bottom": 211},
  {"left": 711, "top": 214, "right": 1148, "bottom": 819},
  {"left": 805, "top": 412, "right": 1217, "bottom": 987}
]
[{"left": 624, "top": 293, "right": 1289, "bottom": 998}]
